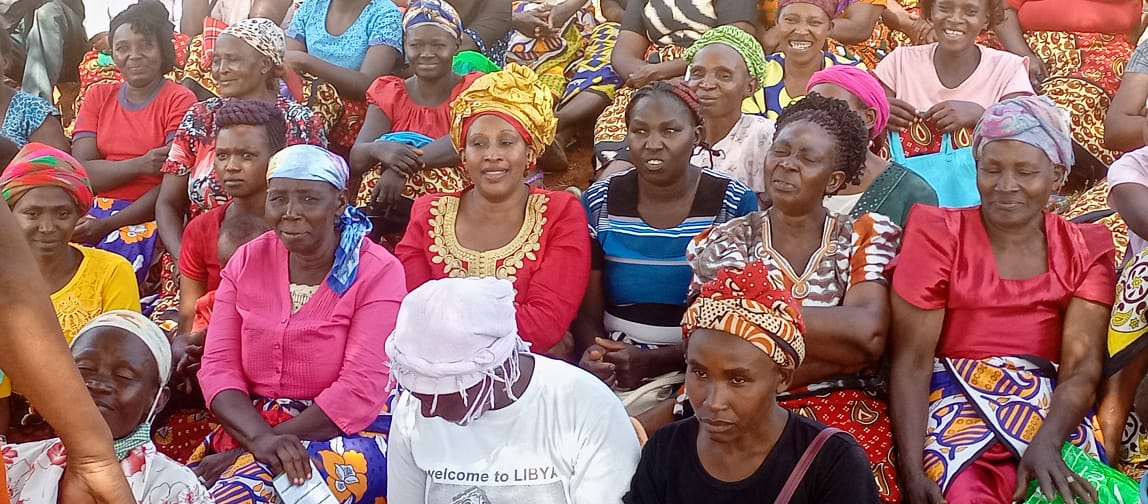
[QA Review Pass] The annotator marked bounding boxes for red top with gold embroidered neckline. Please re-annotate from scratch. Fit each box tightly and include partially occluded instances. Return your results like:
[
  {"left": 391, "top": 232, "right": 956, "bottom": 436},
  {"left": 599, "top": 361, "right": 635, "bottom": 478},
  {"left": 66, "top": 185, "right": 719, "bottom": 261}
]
[{"left": 395, "top": 189, "right": 592, "bottom": 352}]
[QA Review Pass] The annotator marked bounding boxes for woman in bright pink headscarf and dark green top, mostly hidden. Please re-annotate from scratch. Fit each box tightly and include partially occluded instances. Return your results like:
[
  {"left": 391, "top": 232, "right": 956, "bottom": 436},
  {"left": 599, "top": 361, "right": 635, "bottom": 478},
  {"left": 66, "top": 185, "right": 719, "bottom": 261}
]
[{"left": 809, "top": 65, "right": 937, "bottom": 226}]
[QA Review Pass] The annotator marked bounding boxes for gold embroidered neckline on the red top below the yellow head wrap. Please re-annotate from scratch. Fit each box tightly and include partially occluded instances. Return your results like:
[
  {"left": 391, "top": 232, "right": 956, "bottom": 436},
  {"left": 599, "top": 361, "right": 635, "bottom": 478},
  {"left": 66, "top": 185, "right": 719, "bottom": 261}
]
[{"left": 431, "top": 193, "right": 550, "bottom": 281}]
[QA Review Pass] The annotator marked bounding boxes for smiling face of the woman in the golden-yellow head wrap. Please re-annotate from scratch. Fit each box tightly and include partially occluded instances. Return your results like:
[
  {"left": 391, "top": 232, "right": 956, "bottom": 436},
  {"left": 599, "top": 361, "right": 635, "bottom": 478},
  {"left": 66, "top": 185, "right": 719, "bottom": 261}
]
[{"left": 459, "top": 114, "right": 534, "bottom": 201}]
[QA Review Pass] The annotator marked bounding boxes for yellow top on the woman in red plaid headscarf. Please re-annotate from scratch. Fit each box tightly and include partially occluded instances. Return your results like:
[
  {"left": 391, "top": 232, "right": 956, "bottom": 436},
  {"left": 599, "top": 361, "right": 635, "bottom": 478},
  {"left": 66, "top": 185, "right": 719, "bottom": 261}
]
[{"left": 0, "top": 245, "right": 140, "bottom": 397}]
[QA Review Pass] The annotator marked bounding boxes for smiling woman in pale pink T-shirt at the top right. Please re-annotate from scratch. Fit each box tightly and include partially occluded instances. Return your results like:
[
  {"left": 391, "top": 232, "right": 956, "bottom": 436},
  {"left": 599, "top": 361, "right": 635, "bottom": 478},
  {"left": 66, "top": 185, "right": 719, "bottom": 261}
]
[{"left": 875, "top": 0, "right": 1033, "bottom": 136}]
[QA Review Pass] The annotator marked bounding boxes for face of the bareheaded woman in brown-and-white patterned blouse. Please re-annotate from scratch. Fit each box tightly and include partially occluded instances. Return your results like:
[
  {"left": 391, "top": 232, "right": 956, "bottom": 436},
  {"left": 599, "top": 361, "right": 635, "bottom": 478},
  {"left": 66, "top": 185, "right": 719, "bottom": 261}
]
[{"left": 766, "top": 121, "right": 845, "bottom": 215}]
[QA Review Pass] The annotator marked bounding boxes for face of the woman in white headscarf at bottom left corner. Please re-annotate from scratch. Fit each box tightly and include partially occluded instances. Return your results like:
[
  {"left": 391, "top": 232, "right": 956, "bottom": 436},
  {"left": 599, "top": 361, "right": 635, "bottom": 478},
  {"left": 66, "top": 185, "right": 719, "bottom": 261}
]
[{"left": 72, "top": 327, "right": 168, "bottom": 439}]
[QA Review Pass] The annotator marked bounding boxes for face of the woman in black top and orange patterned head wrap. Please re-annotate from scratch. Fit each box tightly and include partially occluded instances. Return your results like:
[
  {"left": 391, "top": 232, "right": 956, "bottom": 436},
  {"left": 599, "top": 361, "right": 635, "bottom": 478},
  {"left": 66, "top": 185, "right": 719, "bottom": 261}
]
[{"left": 685, "top": 328, "right": 792, "bottom": 442}]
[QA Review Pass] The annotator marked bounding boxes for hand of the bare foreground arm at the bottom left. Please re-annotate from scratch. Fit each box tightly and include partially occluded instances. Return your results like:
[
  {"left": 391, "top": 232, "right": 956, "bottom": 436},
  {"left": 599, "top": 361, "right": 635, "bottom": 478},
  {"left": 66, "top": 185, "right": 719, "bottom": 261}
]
[{"left": 60, "top": 457, "right": 135, "bottom": 504}]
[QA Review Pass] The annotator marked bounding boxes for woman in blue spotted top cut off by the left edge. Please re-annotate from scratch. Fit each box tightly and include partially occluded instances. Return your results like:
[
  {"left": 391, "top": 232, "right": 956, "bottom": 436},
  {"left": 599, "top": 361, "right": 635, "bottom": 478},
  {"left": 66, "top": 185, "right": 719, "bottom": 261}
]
[{"left": 0, "top": 31, "right": 70, "bottom": 152}]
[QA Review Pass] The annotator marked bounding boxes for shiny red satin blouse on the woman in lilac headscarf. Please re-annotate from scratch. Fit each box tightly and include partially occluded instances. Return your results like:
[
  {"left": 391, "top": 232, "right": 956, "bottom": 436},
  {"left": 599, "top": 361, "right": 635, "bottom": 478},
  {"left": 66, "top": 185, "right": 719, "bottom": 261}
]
[{"left": 890, "top": 204, "right": 1116, "bottom": 362}]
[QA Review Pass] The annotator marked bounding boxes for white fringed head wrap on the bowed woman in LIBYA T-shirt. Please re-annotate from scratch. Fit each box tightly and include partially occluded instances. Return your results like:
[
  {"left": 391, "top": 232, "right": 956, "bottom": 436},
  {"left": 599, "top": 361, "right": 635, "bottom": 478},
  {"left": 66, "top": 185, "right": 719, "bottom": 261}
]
[{"left": 387, "top": 277, "right": 529, "bottom": 424}]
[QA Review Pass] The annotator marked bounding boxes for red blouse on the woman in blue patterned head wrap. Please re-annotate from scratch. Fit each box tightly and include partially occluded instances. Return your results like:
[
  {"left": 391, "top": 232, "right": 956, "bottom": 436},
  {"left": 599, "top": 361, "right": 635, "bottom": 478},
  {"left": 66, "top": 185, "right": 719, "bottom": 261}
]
[{"left": 366, "top": 72, "right": 482, "bottom": 138}]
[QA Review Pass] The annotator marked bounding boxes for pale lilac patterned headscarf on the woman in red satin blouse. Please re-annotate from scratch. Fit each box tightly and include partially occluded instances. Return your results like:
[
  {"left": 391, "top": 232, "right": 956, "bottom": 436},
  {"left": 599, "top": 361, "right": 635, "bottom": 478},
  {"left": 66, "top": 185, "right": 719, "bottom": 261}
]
[{"left": 972, "top": 96, "right": 1075, "bottom": 176}]
